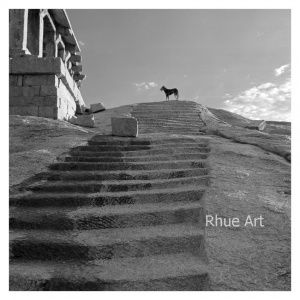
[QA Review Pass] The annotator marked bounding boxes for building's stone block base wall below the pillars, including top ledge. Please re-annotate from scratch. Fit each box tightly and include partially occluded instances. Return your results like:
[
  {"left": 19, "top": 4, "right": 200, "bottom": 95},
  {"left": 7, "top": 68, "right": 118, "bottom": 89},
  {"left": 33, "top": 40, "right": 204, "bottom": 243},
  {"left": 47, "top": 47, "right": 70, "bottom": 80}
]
[{"left": 9, "top": 56, "right": 84, "bottom": 120}]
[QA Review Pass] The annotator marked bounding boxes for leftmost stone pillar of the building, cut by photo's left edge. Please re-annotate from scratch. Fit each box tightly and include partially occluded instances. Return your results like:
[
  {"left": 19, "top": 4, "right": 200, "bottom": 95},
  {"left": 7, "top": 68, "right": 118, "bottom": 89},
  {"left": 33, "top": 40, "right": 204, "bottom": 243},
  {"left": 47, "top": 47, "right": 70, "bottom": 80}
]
[{"left": 9, "top": 9, "right": 30, "bottom": 57}]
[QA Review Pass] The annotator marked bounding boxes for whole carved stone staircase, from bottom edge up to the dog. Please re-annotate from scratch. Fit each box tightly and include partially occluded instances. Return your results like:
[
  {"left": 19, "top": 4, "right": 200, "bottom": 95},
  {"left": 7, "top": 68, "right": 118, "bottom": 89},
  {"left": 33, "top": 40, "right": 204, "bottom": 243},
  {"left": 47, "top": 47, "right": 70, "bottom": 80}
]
[{"left": 10, "top": 101, "right": 210, "bottom": 291}]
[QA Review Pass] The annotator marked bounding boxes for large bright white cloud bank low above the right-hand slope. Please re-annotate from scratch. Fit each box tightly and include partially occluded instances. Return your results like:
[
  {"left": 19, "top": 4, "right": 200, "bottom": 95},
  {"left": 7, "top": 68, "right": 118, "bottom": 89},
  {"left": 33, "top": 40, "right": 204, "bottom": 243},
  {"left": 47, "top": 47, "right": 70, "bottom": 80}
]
[{"left": 223, "top": 78, "right": 291, "bottom": 121}]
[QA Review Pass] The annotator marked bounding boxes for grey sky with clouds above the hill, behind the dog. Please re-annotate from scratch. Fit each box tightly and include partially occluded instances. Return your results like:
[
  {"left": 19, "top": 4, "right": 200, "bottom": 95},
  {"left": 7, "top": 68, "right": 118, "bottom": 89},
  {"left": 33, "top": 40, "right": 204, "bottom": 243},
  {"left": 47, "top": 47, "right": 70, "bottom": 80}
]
[{"left": 67, "top": 9, "right": 291, "bottom": 121}]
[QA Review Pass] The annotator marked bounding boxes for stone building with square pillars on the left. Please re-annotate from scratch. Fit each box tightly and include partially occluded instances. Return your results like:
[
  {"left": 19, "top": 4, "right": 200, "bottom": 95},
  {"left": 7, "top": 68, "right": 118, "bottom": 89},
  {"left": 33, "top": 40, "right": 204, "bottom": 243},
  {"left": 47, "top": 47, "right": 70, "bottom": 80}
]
[{"left": 9, "top": 9, "right": 85, "bottom": 120}]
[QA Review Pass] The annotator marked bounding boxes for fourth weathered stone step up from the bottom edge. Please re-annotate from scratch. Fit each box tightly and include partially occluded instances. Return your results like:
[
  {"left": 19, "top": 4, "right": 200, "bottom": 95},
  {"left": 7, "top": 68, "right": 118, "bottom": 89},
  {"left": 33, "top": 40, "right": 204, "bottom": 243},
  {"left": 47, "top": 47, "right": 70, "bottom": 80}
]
[{"left": 9, "top": 186, "right": 205, "bottom": 207}]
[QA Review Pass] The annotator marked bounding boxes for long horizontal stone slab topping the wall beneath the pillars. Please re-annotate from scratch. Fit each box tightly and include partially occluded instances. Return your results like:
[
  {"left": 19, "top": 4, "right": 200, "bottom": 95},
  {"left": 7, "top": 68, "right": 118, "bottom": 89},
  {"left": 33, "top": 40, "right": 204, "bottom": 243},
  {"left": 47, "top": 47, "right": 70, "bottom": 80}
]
[{"left": 11, "top": 55, "right": 64, "bottom": 76}]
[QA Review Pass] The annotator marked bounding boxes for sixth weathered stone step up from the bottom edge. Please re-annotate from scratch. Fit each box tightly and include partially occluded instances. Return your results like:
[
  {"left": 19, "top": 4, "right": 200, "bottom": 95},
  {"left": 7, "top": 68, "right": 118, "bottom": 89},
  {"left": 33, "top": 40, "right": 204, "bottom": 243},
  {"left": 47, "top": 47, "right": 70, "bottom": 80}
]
[{"left": 38, "top": 168, "right": 209, "bottom": 181}]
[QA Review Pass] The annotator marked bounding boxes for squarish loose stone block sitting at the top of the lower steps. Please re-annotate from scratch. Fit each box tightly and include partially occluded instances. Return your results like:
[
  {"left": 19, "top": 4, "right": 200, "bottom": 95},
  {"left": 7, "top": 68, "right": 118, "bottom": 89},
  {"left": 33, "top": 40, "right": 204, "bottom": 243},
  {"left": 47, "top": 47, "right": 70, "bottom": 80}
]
[{"left": 111, "top": 117, "right": 138, "bottom": 137}]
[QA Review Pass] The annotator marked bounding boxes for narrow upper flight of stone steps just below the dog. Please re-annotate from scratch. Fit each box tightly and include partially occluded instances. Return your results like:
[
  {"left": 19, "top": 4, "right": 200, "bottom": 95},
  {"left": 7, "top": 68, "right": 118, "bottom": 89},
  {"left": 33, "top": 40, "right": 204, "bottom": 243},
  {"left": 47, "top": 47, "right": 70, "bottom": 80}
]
[{"left": 131, "top": 101, "right": 204, "bottom": 135}]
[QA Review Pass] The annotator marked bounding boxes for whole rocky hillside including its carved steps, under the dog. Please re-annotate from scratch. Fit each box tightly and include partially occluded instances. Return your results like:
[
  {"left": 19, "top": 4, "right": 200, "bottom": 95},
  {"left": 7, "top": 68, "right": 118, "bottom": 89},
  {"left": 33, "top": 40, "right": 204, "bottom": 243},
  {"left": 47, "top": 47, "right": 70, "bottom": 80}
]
[{"left": 10, "top": 101, "right": 291, "bottom": 291}]
